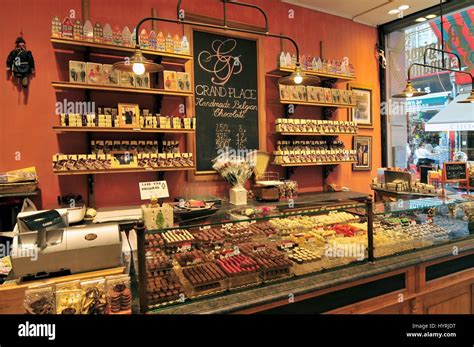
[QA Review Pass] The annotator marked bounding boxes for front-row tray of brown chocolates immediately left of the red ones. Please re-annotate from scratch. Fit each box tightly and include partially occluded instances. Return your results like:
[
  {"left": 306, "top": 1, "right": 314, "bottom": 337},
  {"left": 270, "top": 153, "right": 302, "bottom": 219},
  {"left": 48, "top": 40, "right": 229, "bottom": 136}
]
[{"left": 182, "top": 263, "right": 227, "bottom": 297}]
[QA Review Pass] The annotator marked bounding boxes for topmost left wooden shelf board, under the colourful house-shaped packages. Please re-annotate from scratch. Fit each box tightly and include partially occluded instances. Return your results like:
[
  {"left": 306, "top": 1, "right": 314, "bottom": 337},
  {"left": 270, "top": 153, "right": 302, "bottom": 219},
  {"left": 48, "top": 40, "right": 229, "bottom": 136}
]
[{"left": 51, "top": 37, "right": 193, "bottom": 64}]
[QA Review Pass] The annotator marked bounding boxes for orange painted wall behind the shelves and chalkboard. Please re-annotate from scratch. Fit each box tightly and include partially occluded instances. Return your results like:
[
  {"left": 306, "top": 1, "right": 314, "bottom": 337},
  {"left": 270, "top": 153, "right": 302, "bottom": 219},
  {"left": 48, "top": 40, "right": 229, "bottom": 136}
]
[{"left": 0, "top": 0, "right": 381, "bottom": 208}]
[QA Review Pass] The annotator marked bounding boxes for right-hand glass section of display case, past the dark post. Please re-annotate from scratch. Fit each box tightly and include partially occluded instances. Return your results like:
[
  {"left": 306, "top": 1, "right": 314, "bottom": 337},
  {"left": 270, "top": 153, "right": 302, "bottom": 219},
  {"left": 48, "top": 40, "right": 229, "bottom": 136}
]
[{"left": 373, "top": 196, "right": 474, "bottom": 258}]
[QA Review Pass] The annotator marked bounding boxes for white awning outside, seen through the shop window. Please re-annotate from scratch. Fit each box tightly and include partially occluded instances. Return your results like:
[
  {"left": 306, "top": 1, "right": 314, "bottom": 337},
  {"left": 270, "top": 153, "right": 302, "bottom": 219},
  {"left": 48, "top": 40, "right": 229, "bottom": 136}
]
[{"left": 425, "top": 93, "right": 474, "bottom": 131}]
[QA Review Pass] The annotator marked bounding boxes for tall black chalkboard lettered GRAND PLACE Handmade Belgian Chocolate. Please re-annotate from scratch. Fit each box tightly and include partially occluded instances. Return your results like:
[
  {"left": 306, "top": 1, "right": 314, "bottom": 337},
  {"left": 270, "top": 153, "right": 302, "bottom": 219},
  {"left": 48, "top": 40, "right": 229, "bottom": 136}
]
[{"left": 193, "top": 30, "right": 259, "bottom": 173}]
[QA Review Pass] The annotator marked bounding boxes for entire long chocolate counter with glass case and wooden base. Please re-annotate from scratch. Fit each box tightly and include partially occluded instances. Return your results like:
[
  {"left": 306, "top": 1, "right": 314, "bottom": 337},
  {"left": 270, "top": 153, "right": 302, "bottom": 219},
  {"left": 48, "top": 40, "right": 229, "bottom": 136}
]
[{"left": 137, "top": 193, "right": 474, "bottom": 314}]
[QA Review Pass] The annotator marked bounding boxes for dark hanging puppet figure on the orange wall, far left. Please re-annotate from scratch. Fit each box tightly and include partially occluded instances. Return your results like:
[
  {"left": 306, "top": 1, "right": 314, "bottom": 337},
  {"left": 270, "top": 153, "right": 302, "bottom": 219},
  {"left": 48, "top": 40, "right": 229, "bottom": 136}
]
[{"left": 7, "top": 37, "right": 35, "bottom": 88}]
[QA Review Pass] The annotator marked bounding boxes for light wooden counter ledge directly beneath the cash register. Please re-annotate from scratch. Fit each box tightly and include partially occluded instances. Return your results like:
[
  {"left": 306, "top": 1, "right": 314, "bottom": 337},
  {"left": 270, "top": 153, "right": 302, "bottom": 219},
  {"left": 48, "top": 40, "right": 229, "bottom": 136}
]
[{"left": 0, "top": 267, "right": 124, "bottom": 314}]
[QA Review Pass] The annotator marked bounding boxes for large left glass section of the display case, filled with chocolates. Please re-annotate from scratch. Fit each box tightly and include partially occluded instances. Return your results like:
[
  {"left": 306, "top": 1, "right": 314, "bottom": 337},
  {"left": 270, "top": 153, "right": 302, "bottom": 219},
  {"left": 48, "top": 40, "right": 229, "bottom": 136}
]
[{"left": 139, "top": 195, "right": 372, "bottom": 310}]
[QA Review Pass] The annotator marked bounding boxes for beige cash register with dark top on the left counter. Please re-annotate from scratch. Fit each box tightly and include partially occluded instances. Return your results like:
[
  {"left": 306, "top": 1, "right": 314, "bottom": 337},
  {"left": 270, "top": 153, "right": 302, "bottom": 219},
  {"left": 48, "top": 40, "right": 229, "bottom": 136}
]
[{"left": 11, "top": 209, "right": 122, "bottom": 279}]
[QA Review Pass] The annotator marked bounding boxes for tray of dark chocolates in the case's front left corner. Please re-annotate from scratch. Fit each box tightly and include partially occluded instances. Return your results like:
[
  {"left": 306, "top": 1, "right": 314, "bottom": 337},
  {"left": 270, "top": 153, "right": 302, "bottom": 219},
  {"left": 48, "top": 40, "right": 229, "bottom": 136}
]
[{"left": 147, "top": 274, "right": 184, "bottom": 306}]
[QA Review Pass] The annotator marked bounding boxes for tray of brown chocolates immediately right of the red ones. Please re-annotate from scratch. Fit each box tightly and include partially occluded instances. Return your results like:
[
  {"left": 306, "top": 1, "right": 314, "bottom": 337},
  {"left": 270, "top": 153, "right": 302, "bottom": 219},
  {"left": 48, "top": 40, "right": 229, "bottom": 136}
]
[{"left": 239, "top": 243, "right": 293, "bottom": 282}]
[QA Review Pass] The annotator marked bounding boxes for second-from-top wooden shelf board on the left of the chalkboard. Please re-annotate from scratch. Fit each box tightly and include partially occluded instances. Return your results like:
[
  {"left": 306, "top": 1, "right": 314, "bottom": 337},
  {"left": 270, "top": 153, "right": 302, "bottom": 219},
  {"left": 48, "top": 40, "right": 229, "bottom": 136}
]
[{"left": 51, "top": 82, "right": 193, "bottom": 97}]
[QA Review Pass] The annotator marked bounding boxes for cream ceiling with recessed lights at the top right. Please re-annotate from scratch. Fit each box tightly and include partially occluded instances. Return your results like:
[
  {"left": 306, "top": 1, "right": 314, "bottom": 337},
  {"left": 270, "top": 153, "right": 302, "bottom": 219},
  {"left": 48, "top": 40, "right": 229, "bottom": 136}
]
[{"left": 281, "top": 0, "right": 439, "bottom": 26}]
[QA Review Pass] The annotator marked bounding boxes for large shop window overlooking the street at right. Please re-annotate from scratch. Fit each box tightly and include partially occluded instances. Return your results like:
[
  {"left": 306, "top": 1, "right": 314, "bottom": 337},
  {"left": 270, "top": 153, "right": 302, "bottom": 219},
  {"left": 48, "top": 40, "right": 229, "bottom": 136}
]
[{"left": 382, "top": 6, "right": 474, "bottom": 170}]
